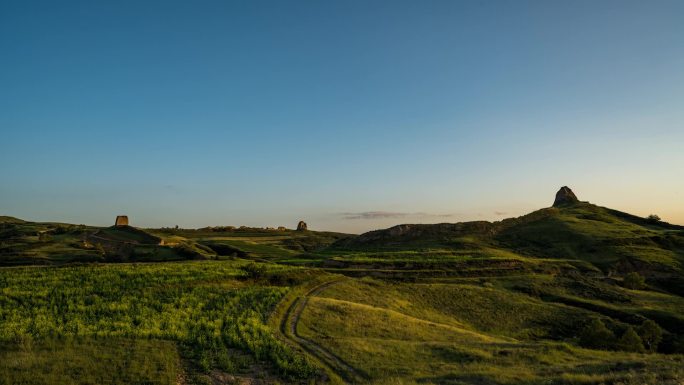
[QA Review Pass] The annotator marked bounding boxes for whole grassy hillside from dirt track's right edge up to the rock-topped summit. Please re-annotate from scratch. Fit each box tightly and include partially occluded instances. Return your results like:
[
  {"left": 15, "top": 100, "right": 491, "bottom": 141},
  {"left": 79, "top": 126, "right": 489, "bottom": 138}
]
[{"left": 264, "top": 192, "right": 684, "bottom": 384}]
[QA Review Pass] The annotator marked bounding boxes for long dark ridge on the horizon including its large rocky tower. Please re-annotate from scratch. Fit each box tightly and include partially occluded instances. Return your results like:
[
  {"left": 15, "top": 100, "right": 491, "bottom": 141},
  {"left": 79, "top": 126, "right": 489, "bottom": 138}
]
[{"left": 329, "top": 187, "right": 684, "bottom": 280}]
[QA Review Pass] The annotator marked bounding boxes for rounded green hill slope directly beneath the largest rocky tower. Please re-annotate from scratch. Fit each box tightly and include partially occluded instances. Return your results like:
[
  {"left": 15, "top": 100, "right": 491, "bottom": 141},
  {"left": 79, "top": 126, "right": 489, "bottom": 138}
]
[{"left": 493, "top": 203, "right": 684, "bottom": 270}]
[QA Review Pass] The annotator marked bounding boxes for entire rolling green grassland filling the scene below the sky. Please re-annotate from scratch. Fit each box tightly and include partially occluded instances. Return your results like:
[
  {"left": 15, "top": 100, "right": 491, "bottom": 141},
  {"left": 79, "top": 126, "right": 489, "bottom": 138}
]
[{"left": 0, "top": 189, "right": 684, "bottom": 385}]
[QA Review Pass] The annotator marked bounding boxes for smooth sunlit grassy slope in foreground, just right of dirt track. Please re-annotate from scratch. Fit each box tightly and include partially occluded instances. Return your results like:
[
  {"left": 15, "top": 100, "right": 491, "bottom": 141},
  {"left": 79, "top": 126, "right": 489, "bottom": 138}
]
[{"left": 299, "top": 277, "right": 684, "bottom": 384}]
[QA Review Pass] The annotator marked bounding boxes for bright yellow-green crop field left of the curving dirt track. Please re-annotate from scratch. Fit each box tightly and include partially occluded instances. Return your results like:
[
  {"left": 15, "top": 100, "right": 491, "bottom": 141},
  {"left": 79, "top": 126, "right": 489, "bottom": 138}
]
[{"left": 0, "top": 261, "right": 314, "bottom": 379}]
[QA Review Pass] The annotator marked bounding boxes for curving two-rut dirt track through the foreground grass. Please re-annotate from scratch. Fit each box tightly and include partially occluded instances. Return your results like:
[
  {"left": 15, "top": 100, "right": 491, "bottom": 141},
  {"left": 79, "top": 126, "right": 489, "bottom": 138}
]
[{"left": 280, "top": 280, "right": 364, "bottom": 383}]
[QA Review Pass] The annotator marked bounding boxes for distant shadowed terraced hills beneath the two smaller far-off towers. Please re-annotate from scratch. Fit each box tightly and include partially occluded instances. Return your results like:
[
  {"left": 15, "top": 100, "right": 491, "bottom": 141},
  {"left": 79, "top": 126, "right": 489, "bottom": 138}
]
[{"left": 0, "top": 217, "right": 347, "bottom": 266}]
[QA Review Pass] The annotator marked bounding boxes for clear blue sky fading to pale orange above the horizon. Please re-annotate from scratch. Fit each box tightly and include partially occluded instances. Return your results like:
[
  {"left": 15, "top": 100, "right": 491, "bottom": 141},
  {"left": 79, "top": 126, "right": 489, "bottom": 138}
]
[{"left": 0, "top": 0, "right": 684, "bottom": 232}]
